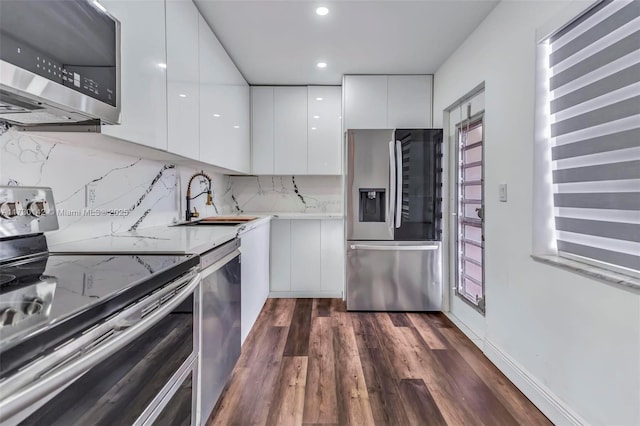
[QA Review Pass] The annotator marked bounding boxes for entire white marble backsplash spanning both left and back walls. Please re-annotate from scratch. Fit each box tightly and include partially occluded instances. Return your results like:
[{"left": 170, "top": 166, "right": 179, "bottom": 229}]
[{"left": 0, "top": 123, "right": 342, "bottom": 244}]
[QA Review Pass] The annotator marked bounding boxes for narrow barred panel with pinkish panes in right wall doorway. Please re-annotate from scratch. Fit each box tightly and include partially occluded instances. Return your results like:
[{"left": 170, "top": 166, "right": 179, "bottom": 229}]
[{"left": 456, "top": 114, "right": 485, "bottom": 313}]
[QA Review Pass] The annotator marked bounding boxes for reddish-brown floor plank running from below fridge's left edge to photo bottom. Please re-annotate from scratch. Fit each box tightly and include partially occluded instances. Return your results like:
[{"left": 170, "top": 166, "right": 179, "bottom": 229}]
[{"left": 333, "top": 313, "right": 373, "bottom": 425}]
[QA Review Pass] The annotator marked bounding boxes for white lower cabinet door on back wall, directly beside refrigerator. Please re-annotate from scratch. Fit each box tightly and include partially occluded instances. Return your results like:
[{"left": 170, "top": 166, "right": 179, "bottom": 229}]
[{"left": 320, "top": 219, "right": 345, "bottom": 293}]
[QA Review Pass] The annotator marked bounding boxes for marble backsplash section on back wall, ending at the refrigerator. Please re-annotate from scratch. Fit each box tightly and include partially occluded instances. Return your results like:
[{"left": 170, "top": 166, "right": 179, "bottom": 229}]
[{"left": 230, "top": 176, "right": 343, "bottom": 213}]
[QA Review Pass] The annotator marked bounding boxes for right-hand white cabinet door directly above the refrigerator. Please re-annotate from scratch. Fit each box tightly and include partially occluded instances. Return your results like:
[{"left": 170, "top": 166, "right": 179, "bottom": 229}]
[{"left": 387, "top": 75, "right": 433, "bottom": 129}]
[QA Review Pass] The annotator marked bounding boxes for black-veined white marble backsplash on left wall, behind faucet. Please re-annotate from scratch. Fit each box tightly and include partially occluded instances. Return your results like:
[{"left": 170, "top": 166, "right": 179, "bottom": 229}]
[{"left": 0, "top": 127, "right": 235, "bottom": 243}]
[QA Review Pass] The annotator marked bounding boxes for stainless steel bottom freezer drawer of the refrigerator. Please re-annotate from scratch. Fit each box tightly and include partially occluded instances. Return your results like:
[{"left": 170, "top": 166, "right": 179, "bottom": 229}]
[{"left": 347, "top": 241, "right": 442, "bottom": 311}]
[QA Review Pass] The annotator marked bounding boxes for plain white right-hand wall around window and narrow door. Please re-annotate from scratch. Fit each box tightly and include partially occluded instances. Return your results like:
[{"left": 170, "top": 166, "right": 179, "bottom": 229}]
[{"left": 434, "top": 1, "right": 640, "bottom": 425}]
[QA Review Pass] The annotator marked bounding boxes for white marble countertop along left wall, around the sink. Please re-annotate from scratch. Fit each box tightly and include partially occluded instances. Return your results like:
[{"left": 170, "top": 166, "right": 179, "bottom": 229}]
[{"left": 49, "top": 216, "right": 271, "bottom": 254}]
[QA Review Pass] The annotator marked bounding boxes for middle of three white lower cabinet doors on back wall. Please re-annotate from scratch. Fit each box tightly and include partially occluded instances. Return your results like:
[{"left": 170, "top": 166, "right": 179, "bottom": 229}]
[{"left": 291, "top": 220, "right": 321, "bottom": 292}]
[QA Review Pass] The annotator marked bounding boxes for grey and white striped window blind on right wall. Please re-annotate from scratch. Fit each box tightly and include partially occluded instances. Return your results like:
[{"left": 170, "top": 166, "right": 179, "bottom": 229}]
[{"left": 548, "top": 0, "right": 640, "bottom": 271}]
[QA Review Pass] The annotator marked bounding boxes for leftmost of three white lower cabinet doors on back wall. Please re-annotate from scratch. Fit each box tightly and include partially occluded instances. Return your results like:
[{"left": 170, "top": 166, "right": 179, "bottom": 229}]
[{"left": 270, "top": 219, "right": 291, "bottom": 292}]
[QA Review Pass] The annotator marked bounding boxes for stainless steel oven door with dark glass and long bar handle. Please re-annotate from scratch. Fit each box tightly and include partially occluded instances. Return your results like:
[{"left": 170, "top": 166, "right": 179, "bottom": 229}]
[{"left": 0, "top": 271, "right": 200, "bottom": 425}]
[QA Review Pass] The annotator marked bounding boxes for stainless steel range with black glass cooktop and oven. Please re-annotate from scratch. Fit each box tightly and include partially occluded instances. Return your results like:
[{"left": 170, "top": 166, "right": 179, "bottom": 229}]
[{"left": 0, "top": 186, "right": 202, "bottom": 426}]
